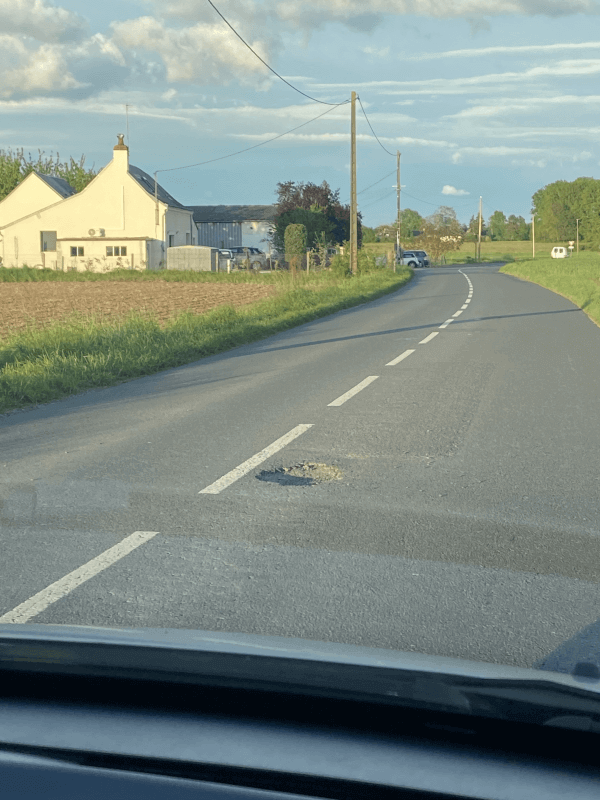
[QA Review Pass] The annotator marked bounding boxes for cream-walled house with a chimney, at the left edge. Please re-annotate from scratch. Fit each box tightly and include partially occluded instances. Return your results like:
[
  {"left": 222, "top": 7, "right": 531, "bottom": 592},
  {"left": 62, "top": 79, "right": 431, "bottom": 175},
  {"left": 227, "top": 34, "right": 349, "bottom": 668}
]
[{"left": 0, "top": 134, "right": 197, "bottom": 272}]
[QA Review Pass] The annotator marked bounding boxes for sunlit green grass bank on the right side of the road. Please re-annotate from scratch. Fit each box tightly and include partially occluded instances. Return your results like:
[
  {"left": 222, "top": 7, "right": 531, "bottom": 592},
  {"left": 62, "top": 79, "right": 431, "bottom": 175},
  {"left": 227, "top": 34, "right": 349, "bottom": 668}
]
[{"left": 500, "top": 253, "right": 600, "bottom": 327}]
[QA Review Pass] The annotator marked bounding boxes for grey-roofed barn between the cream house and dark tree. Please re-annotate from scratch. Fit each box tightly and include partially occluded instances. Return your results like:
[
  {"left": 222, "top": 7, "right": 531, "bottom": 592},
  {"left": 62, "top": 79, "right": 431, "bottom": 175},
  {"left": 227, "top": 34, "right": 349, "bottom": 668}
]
[{"left": 188, "top": 205, "right": 277, "bottom": 252}]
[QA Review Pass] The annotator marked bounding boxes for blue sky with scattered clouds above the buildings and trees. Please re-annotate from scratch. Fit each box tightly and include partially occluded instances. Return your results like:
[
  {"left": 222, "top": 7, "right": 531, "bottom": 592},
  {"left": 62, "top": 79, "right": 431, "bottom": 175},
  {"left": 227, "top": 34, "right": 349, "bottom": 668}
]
[{"left": 0, "top": 0, "right": 600, "bottom": 226}]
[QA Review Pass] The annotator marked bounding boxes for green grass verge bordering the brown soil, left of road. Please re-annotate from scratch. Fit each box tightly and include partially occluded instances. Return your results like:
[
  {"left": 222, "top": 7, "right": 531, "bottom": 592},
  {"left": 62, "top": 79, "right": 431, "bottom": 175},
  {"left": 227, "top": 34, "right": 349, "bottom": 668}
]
[{"left": 0, "top": 268, "right": 413, "bottom": 414}]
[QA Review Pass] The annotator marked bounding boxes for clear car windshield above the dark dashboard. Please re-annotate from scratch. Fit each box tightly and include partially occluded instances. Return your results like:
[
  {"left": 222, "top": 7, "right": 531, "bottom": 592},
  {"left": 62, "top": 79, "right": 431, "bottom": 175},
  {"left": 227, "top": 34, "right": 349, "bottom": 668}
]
[{"left": 0, "top": 0, "right": 600, "bottom": 708}]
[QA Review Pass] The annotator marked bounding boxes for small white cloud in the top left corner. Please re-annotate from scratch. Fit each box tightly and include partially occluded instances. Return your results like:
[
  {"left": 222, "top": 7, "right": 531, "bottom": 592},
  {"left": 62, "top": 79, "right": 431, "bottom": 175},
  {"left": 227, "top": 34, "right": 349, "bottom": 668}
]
[{"left": 0, "top": 0, "right": 86, "bottom": 42}]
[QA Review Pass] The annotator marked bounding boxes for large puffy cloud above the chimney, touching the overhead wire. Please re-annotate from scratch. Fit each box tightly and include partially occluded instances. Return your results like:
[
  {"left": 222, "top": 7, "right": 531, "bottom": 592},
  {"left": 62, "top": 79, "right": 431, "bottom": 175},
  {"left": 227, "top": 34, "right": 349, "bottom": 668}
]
[{"left": 112, "top": 17, "right": 280, "bottom": 88}]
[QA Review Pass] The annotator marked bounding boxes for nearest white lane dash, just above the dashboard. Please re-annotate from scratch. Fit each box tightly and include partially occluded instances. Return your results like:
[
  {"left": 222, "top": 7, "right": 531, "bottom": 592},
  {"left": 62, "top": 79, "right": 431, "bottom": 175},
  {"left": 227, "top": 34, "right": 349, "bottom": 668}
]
[{"left": 0, "top": 531, "right": 158, "bottom": 624}]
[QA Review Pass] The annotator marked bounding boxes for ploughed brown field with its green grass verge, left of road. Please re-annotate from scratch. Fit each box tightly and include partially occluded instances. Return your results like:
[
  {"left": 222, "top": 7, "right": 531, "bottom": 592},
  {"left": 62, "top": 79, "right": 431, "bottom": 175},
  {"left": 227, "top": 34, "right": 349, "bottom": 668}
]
[{"left": 0, "top": 267, "right": 414, "bottom": 414}]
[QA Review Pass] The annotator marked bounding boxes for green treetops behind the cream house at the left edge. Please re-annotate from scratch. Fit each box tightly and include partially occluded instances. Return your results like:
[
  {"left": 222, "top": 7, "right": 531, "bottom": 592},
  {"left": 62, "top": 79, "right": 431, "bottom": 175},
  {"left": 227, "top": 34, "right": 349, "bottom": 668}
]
[{"left": 0, "top": 149, "right": 97, "bottom": 200}]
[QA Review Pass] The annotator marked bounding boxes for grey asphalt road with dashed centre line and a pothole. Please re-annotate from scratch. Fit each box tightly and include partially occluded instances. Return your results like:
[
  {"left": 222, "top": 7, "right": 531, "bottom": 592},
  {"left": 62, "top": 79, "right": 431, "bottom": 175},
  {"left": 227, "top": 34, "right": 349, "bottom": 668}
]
[{"left": 0, "top": 265, "right": 600, "bottom": 666}]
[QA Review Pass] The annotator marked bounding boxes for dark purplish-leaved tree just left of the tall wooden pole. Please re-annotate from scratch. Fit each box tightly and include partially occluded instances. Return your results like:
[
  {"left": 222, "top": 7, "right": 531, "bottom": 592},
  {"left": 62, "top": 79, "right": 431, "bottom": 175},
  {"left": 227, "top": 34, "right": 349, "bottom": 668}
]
[{"left": 271, "top": 181, "right": 362, "bottom": 252}]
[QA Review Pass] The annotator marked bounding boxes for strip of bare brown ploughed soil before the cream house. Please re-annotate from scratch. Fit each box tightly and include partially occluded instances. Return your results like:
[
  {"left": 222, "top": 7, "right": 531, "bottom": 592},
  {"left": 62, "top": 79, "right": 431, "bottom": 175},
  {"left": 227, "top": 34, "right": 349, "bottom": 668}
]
[{"left": 0, "top": 281, "right": 277, "bottom": 339}]
